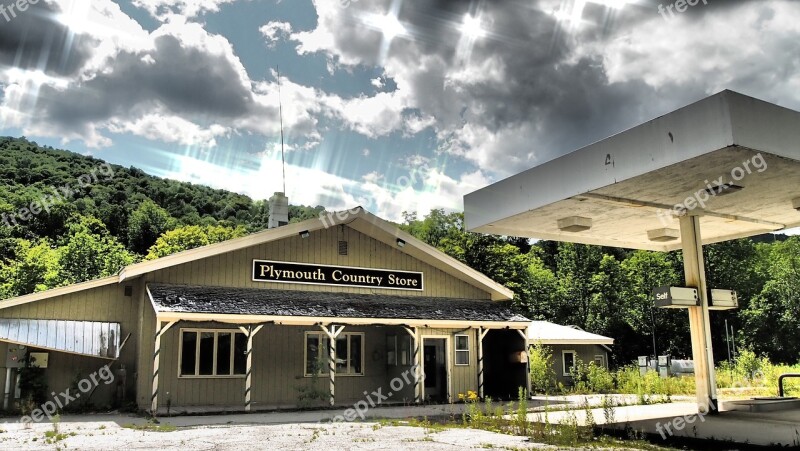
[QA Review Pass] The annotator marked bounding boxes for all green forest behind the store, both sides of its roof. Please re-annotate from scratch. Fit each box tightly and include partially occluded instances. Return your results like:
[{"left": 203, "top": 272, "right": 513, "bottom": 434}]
[{"left": 0, "top": 138, "right": 800, "bottom": 363}]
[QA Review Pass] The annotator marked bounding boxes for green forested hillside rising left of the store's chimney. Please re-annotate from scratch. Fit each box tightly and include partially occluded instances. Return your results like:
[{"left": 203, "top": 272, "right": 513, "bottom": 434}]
[{"left": 0, "top": 137, "right": 323, "bottom": 298}]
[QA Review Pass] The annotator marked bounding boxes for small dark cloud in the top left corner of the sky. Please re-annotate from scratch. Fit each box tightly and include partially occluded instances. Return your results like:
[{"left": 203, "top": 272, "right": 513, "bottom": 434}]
[{"left": 0, "top": 0, "right": 98, "bottom": 76}]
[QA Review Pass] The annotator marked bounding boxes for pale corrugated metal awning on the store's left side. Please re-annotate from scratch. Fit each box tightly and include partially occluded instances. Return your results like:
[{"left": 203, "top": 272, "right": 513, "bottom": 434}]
[{"left": 0, "top": 318, "right": 120, "bottom": 359}]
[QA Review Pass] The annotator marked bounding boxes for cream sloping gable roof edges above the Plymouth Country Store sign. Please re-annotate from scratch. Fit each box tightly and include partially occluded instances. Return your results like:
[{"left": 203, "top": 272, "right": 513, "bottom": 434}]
[{"left": 0, "top": 207, "right": 514, "bottom": 309}]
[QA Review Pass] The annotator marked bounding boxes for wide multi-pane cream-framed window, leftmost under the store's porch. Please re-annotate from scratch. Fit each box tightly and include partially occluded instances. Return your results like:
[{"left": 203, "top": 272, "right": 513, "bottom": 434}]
[{"left": 179, "top": 329, "right": 247, "bottom": 377}]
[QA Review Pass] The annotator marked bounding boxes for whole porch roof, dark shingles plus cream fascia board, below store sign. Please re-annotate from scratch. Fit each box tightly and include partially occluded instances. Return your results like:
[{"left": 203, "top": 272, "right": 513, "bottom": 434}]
[{"left": 147, "top": 284, "right": 530, "bottom": 329}]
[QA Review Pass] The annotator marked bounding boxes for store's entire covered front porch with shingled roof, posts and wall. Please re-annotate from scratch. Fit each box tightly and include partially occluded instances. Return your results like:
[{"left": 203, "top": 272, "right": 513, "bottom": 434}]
[{"left": 145, "top": 284, "right": 528, "bottom": 413}]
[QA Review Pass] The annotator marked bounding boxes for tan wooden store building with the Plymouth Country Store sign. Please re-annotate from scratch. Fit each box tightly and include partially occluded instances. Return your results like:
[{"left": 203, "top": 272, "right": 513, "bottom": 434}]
[{"left": 0, "top": 207, "right": 529, "bottom": 412}]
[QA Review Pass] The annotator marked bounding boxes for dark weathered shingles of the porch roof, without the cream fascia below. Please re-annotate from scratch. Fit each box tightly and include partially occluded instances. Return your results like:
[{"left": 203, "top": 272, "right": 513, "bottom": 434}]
[{"left": 147, "top": 284, "right": 530, "bottom": 322}]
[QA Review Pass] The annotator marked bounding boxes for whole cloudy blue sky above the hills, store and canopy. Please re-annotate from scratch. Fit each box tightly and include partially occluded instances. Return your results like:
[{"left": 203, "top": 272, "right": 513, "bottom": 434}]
[{"left": 0, "top": 0, "right": 800, "bottom": 220}]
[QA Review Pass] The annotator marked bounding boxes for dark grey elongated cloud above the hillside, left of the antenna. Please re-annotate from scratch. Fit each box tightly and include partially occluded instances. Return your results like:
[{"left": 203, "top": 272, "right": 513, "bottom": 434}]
[{"left": 32, "top": 35, "right": 255, "bottom": 127}]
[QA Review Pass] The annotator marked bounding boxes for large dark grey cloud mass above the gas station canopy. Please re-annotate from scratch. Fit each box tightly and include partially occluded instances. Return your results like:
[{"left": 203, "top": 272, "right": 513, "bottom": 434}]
[{"left": 308, "top": 0, "right": 800, "bottom": 175}]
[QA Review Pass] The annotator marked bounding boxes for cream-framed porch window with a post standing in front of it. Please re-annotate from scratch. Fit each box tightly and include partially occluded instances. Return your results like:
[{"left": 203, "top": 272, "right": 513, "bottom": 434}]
[{"left": 305, "top": 332, "right": 364, "bottom": 377}]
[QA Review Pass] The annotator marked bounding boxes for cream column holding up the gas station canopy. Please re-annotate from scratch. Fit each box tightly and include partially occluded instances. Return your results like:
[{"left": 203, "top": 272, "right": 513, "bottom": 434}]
[{"left": 680, "top": 215, "right": 719, "bottom": 413}]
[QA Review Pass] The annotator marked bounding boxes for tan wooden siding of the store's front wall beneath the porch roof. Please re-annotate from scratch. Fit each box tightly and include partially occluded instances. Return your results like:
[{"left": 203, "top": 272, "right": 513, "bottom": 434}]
[{"left": 139, "top": 321, "right": 477, "bottom": 408}]
